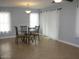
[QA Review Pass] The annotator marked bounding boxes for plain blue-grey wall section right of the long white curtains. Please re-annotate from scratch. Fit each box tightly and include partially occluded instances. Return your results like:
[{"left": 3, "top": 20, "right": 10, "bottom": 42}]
[{"left": 59, "top": 5, "right": 77, "bottom": 43}]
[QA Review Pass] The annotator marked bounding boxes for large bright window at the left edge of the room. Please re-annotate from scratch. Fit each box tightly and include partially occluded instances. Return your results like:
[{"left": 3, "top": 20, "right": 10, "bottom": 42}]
[{"left": 0, "top": 12, "right": 10, "bottom": 32}]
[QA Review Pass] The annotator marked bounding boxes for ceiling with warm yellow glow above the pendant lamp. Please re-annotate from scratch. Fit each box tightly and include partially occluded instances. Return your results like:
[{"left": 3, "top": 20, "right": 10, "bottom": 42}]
[{"left": 0, "top": 0, "right": 52, "bottom": 9}]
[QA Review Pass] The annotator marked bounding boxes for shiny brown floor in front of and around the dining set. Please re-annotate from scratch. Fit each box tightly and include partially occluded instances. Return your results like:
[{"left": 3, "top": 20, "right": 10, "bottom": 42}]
[{"left": 0, "top": 37, "right": 79, "bottom": 59}]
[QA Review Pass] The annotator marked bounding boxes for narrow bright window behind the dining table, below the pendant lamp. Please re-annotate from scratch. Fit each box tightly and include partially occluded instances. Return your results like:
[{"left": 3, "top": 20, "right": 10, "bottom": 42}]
[{"left": 30, "top": 13, "right": 39, "bottom": 27}]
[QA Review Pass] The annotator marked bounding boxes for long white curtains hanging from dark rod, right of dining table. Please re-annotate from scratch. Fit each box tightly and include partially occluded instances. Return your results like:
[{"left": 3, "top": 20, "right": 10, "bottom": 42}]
[{"left": 41, "top": 10, "right": 59, "bottom": 39}]
